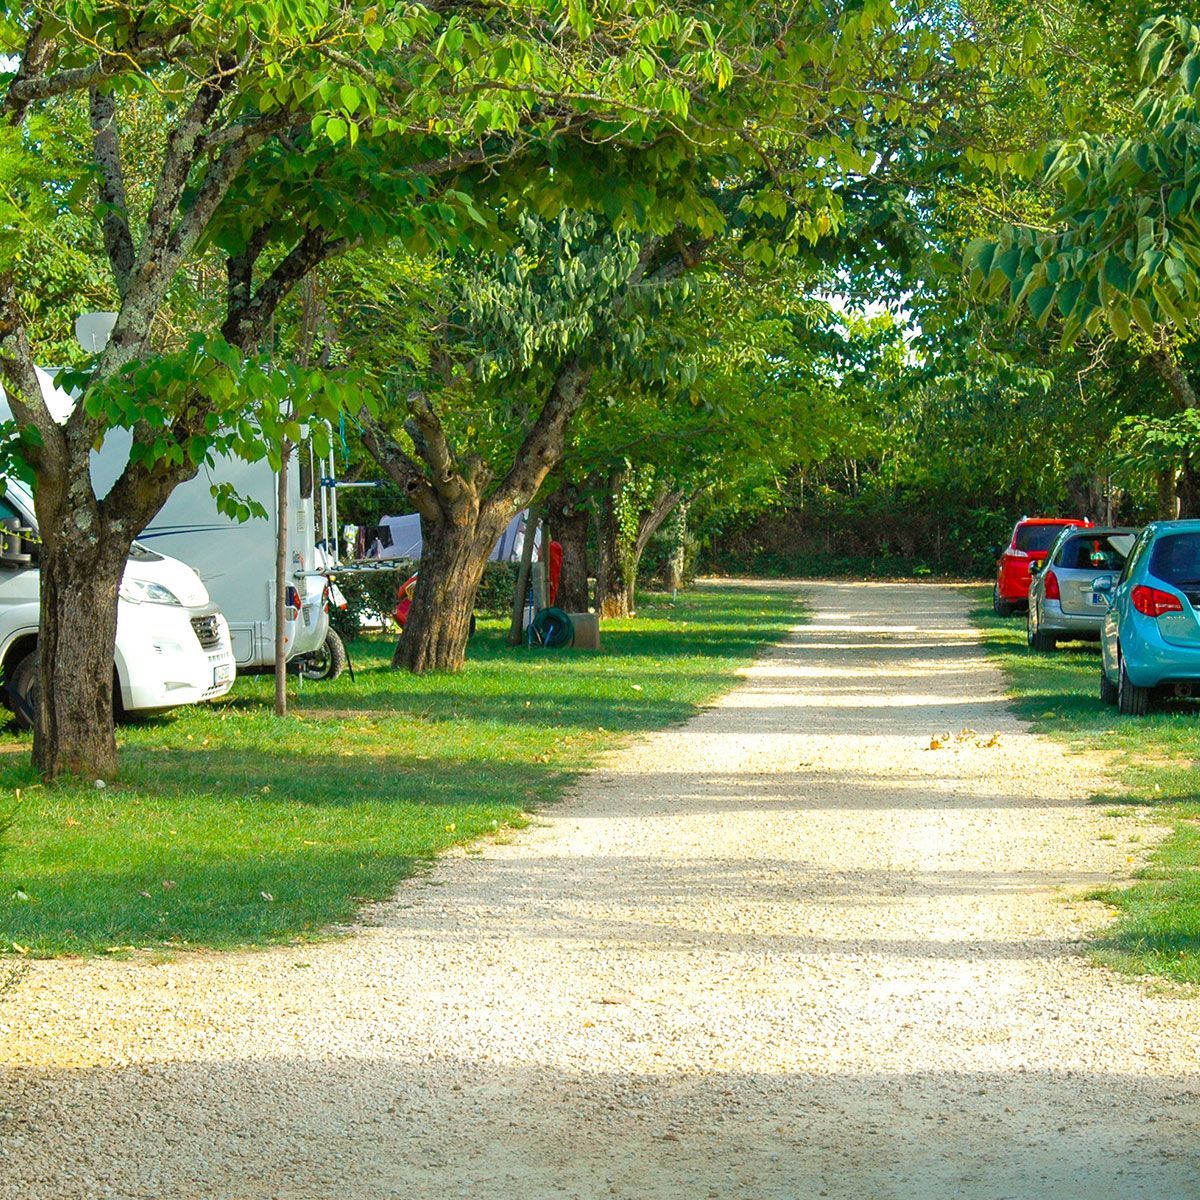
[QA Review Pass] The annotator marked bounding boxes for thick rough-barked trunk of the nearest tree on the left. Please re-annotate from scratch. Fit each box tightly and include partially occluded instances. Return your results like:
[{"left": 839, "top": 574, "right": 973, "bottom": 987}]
[{"left": 34, "top": 532, "right": 128, "bottom": 779}]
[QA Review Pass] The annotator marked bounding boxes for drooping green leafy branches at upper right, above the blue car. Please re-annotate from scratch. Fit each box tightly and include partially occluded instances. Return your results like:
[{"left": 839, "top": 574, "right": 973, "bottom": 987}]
[{"left": 967, "top": 16, "right": 1200, "bottom": 515}]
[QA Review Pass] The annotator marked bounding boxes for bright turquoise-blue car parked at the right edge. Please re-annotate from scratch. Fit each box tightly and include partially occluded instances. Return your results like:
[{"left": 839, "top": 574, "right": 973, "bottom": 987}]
[{"left": 1093, "top": 521, "right": 1200, "bottom": 716}]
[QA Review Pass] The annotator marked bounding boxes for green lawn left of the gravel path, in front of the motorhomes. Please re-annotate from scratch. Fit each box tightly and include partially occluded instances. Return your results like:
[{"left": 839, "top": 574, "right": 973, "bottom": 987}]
[{"left": 0, "top": 587, "right": 799, "bottom": 955}]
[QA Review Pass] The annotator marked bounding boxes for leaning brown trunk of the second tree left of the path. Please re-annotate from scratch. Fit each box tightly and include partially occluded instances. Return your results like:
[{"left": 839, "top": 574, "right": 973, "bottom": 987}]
[{"left": 391, "top": 504, "right": 505, "bottom": 674}]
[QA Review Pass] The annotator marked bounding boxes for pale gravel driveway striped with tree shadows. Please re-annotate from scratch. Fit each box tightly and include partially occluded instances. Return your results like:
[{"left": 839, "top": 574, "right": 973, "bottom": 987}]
[{"left": 0, "top": 584, "right": 1200, "bottom": 1200}]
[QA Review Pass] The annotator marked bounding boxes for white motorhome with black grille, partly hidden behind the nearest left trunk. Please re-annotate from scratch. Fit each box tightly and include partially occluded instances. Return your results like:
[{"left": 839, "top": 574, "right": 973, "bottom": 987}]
[{"left": 0, "top": 475, "right": 236, "bottom": 725}]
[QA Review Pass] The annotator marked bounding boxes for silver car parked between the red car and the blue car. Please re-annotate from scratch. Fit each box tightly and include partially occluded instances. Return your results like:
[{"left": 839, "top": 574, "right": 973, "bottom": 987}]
[{"left": 1026, "top": 528, "right": 1138, "bottom": 650}]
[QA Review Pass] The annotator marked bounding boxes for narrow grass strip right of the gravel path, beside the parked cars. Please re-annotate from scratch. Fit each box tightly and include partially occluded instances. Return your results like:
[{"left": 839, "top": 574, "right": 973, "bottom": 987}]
[{"left": 974, "top": 593, "right": 1200, "bottom": 983}]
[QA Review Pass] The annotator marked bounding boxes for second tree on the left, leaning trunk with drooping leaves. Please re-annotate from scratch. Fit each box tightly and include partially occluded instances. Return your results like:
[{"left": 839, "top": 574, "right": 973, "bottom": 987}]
[{"left": 360, "top": 214, "right": 683, "bottom": 672}]
